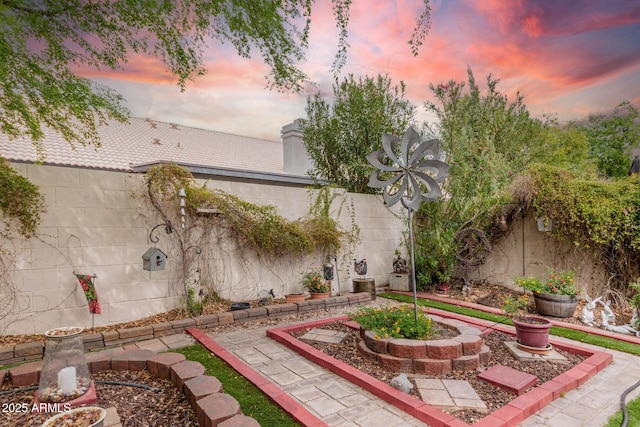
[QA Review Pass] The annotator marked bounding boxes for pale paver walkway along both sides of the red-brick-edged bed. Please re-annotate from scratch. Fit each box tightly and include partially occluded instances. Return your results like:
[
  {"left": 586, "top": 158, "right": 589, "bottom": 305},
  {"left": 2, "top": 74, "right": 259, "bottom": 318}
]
[{"left": 181, "top": 302, "right": 640, "bottom": 427}]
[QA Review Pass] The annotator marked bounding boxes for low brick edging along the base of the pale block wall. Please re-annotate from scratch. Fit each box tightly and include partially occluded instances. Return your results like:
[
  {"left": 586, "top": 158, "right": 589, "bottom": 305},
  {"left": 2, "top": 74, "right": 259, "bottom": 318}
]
[{"left": 0, "top": 292, "right": 371, "bottom": 366}]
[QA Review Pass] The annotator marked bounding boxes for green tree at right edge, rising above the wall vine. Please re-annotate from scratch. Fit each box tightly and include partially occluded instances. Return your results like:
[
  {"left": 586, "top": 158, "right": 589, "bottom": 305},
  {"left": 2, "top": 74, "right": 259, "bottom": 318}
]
[{"left": 581, "top": 101, "right": 640, "bottom": 178}]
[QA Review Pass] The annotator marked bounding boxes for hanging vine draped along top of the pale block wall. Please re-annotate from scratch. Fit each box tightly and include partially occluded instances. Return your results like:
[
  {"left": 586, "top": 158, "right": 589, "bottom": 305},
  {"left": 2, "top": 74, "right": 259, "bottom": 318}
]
[{"left": 145, "top": 164, "right": 359, "bottom": 308}]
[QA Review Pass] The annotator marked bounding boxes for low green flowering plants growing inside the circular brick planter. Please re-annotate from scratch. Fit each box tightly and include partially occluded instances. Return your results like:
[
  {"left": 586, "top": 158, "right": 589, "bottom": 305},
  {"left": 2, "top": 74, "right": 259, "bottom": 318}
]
[{"left": 349, "top": 305, "right": 432, "bottom": 340}]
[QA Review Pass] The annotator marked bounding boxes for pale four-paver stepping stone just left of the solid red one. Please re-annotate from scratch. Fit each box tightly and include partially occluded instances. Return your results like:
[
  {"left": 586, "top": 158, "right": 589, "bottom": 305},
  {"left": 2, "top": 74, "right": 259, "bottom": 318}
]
[{"left": 414, "top": 378, "right": 487, "bottom": 413}]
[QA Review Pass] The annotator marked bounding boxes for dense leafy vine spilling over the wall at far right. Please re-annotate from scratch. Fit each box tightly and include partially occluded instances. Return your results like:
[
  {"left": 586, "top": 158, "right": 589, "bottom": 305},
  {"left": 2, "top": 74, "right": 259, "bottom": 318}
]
[{"left": 516, "top": 164, "right": 640, "bottom": 289}]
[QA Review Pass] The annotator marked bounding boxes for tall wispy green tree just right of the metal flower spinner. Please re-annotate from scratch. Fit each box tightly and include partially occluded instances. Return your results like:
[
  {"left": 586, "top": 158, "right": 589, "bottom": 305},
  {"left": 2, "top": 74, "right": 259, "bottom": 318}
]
[{"left": 415, "top": 69, "right": 548, "bottom": 286}]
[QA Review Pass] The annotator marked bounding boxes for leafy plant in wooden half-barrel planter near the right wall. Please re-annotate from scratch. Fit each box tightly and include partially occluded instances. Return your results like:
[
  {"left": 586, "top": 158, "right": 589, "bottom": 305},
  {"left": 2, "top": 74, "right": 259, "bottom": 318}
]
[{"left": 515, "top": 269, "right": 580, "bottom": 317}]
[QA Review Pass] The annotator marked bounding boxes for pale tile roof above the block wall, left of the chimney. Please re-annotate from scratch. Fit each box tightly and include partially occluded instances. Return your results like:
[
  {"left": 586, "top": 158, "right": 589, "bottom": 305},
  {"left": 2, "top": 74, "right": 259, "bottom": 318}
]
[{"left": 0, "top": 117, "right": 283, "bottom": 173}]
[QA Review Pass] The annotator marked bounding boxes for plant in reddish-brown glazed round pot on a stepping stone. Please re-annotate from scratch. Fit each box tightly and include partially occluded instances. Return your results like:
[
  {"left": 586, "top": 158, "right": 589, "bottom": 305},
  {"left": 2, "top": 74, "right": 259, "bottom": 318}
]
[{"left": 502, "top": 295, "right": 551, "bottom": 349}]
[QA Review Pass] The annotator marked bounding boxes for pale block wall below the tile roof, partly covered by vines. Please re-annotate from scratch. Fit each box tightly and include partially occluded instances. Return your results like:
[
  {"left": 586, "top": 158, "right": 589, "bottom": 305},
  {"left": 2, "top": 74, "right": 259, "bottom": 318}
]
[{"left": 0, "top": 163, "right": 403, "bottom": 334}]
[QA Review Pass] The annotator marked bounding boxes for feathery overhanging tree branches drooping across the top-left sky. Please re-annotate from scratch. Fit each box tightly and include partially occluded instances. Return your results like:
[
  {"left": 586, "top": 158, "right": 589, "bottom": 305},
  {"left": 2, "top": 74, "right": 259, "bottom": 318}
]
[{"left": 0, "top": 0, "right": 430, "bottom": 152}]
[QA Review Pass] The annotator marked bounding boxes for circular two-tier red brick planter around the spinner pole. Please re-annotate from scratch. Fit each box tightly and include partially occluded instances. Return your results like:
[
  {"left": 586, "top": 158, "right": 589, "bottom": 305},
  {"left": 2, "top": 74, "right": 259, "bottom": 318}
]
[{"left": 358, "top": 316, "right": 489, "bottom": 375}]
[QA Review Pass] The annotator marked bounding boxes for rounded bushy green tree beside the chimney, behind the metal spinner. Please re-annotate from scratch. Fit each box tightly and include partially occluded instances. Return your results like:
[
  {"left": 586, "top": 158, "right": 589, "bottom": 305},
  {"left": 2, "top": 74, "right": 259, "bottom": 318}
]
[{"left": 301, "top": 75, "right": 416, "bottom": 193}]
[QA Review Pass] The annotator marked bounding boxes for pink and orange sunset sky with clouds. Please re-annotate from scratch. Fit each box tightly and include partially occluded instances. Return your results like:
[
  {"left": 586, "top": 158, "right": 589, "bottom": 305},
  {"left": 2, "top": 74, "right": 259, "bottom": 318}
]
[{"left": 88, "top": 0, "right": 640, "bottom": 141}]
